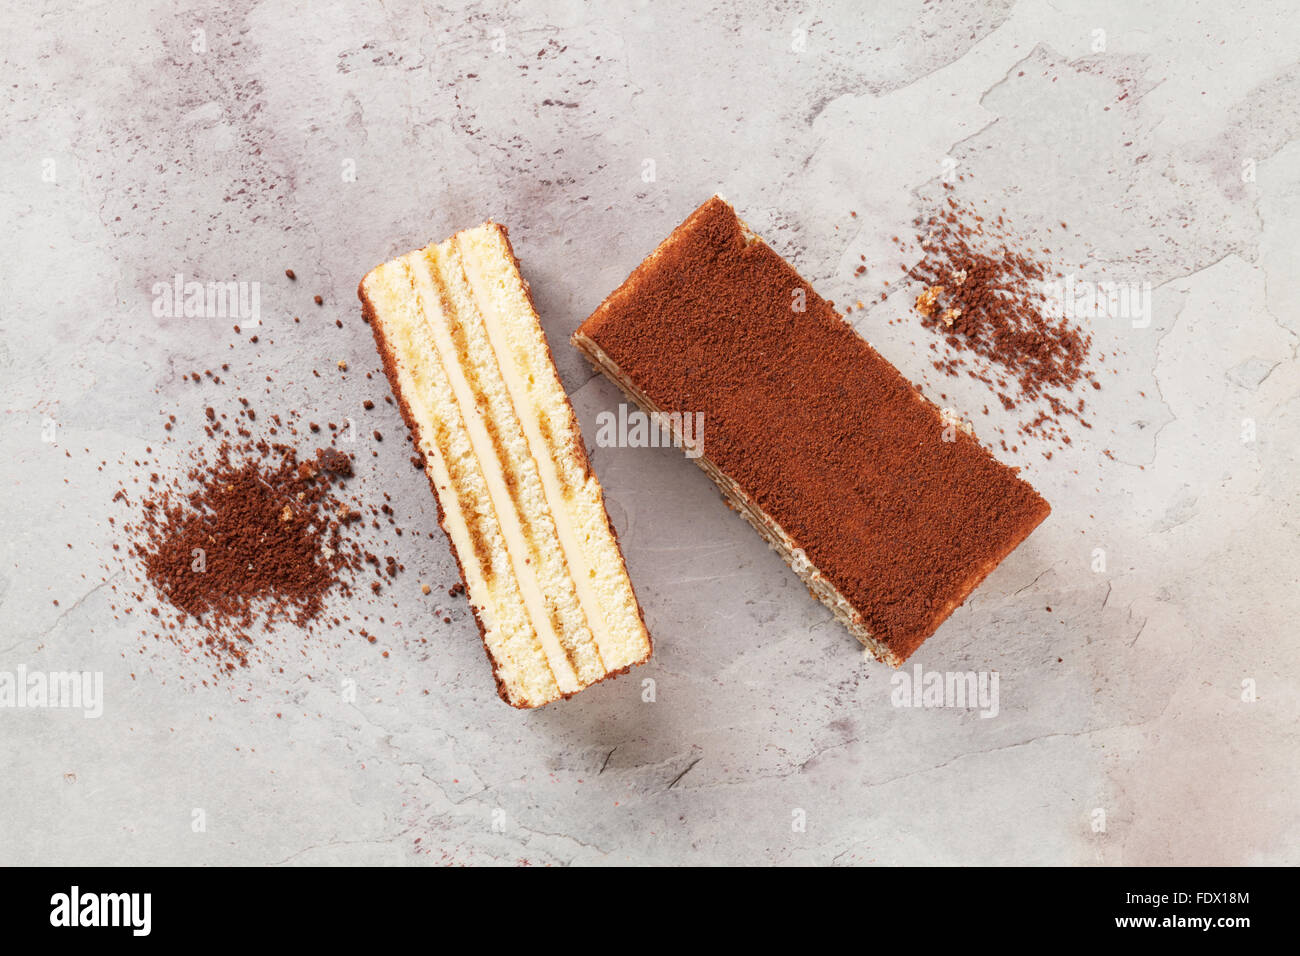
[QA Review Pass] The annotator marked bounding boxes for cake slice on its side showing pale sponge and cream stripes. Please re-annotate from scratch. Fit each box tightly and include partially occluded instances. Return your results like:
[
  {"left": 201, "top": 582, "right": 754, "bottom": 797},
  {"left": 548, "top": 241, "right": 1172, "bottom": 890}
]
[{"left": 358, "top": 222, "right": 650, "bottom": 708}]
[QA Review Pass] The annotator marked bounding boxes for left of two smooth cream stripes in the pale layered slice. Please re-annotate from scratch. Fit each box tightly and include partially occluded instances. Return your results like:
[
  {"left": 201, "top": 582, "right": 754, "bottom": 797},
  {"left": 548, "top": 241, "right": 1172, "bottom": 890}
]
[{"left": 404, "top": 255, "right": 582, "bottom": 693}]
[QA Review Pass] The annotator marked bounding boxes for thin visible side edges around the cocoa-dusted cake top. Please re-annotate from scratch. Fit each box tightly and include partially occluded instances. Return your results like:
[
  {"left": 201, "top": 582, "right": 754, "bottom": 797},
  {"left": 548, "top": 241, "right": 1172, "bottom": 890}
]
[{"left": 569, "top": 194, "right": 1052, "bottom": 667}]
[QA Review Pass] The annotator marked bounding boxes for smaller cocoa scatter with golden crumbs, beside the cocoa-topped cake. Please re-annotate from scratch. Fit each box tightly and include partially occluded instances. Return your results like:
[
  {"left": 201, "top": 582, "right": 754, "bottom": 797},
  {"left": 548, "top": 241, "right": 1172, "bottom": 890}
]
[{"left": 894, "top": 183, "right": 1101, "bottom": 445}]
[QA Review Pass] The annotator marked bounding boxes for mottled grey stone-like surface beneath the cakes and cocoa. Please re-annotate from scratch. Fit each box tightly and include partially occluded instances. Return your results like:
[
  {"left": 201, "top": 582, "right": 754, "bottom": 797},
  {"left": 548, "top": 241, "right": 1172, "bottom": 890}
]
[{"left": 0, "top": 0, "right": 1300, "bottom": 864}]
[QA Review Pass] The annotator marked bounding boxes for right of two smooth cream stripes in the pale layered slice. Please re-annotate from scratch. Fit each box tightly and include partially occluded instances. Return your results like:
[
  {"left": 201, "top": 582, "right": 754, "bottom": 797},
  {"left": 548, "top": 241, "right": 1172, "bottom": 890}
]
[{"left": 456, "top": 235, "right": 615, "bottom": 661}]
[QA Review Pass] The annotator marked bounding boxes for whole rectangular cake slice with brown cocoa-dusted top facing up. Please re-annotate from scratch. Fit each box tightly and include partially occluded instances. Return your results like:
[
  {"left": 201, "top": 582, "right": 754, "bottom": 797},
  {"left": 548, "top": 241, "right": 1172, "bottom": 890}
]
[{"left": 573, "top": 196, "right": 1050, "bottom": 667}]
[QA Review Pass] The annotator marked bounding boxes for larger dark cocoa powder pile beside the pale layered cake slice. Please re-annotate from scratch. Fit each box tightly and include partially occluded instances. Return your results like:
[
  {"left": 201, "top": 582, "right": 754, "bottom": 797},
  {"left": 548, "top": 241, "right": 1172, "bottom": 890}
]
[{"left": 109, "top": 392, "right": 403, "bottom": 684}]
